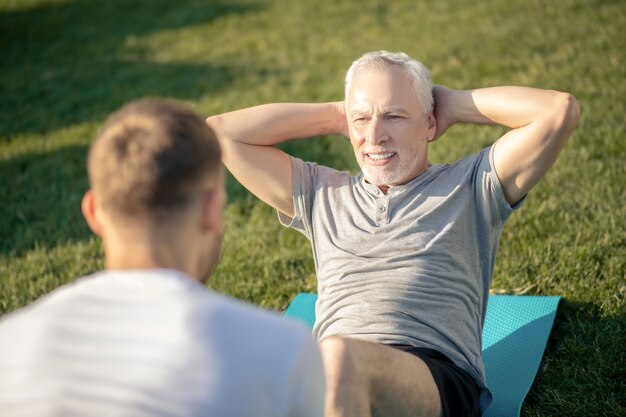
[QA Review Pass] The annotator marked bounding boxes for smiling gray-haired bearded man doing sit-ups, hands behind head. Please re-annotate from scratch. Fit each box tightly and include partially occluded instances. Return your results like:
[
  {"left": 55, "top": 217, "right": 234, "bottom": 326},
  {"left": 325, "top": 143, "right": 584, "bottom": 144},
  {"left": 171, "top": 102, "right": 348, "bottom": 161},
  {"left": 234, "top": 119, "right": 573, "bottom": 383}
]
[{"left": 207, "top": 51, "right": 579, "bottom": 416}]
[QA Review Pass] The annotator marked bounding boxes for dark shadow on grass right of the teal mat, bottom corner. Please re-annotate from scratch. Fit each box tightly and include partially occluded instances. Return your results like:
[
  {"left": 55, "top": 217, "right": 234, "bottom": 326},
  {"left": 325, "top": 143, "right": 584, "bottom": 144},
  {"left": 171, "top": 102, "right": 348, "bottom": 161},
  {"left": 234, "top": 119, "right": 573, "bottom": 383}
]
[{"left": 522, "top": 299, "right": 626, "bottom": 416}]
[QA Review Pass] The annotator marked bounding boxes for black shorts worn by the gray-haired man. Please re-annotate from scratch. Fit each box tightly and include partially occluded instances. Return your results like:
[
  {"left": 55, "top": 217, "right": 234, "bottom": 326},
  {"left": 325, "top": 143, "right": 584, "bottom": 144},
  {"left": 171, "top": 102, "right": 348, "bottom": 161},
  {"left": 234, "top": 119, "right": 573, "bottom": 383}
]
[{"left": 388, "top": 345, "right": 480, "bottom": 417}]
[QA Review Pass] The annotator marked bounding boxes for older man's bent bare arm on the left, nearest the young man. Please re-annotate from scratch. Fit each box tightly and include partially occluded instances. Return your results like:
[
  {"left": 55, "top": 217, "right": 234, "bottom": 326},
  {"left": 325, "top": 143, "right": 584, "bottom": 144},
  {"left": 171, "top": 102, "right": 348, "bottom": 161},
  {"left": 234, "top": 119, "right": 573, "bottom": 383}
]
[{"left": 207, "top": 102, "right": 346, "bottom": 217}]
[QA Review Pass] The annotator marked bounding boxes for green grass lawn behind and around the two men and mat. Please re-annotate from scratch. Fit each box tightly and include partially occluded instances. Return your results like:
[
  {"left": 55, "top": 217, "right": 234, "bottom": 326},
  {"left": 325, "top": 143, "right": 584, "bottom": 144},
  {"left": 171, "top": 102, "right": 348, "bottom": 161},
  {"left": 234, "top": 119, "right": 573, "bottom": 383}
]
[{"left": 0, "top": 0, "right": 626, "bottom": 416}]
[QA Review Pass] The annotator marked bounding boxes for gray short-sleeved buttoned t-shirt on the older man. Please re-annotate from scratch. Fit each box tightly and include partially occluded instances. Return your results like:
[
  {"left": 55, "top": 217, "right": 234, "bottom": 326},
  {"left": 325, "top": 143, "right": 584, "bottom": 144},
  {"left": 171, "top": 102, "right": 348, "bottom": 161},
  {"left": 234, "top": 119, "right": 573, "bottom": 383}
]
[{"left": 279, "top": 147, "right": 519, "bottom": 410}]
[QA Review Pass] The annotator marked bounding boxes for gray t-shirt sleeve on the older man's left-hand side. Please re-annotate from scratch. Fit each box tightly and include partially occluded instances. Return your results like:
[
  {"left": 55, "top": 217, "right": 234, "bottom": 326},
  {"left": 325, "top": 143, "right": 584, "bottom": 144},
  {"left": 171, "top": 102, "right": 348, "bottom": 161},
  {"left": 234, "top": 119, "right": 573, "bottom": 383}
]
[{"left": 278, "top": 156, "right": 318, "bottom": 239}]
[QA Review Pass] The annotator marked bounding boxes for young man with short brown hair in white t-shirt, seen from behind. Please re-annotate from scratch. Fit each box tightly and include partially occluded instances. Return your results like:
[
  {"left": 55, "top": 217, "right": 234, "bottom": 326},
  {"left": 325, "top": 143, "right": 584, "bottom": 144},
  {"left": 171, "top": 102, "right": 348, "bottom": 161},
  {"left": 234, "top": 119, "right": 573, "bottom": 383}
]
[{"left": 0, "top": 99, "right": 324, "bottom": 417}]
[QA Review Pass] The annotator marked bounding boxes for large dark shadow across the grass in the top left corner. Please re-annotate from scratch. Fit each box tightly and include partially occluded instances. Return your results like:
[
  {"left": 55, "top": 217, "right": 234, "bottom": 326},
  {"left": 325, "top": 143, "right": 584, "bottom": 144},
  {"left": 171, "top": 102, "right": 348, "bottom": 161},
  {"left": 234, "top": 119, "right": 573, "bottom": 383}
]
[{"left": 0, "top": 0, "right": 258, "bottom": 137}]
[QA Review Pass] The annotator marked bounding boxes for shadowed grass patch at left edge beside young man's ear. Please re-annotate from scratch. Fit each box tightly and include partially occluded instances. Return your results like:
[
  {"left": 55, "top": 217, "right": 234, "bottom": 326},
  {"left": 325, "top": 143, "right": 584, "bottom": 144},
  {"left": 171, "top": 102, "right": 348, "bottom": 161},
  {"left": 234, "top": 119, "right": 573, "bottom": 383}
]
[{"left": 0, "top": 146, "right": 91, "bottom": 254}]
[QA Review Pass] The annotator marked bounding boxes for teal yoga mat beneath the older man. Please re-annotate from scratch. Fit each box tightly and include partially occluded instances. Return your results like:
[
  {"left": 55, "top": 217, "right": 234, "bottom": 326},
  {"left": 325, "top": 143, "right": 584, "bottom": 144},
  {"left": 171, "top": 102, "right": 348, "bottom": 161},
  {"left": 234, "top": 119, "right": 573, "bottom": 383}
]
[{"left": 285, "top": 293, "right": 561, "bottom": 417}]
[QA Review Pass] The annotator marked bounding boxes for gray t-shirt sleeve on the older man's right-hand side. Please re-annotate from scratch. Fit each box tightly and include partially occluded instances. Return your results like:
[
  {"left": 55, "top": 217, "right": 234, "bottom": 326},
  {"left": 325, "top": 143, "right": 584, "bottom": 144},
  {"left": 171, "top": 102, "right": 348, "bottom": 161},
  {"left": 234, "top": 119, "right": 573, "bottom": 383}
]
[{"left": 472, "top": 145, "right": 526, "bottom": 225}]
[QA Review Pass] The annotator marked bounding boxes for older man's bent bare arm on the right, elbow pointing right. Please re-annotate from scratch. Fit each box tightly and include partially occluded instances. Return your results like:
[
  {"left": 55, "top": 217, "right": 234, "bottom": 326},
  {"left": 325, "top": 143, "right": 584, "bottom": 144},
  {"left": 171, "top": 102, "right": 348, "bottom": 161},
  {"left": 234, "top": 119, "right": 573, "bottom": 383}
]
[{"left": 434, "top": 86, "right": 580, "bottom": 204}]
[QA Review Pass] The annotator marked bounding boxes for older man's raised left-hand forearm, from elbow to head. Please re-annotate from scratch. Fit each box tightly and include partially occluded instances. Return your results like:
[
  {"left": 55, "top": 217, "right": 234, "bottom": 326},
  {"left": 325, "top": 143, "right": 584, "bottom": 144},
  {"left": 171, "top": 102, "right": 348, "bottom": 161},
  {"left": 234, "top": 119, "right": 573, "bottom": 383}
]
[{"left": 207, "top": 103, "right": 345, "bottom": 146}]
